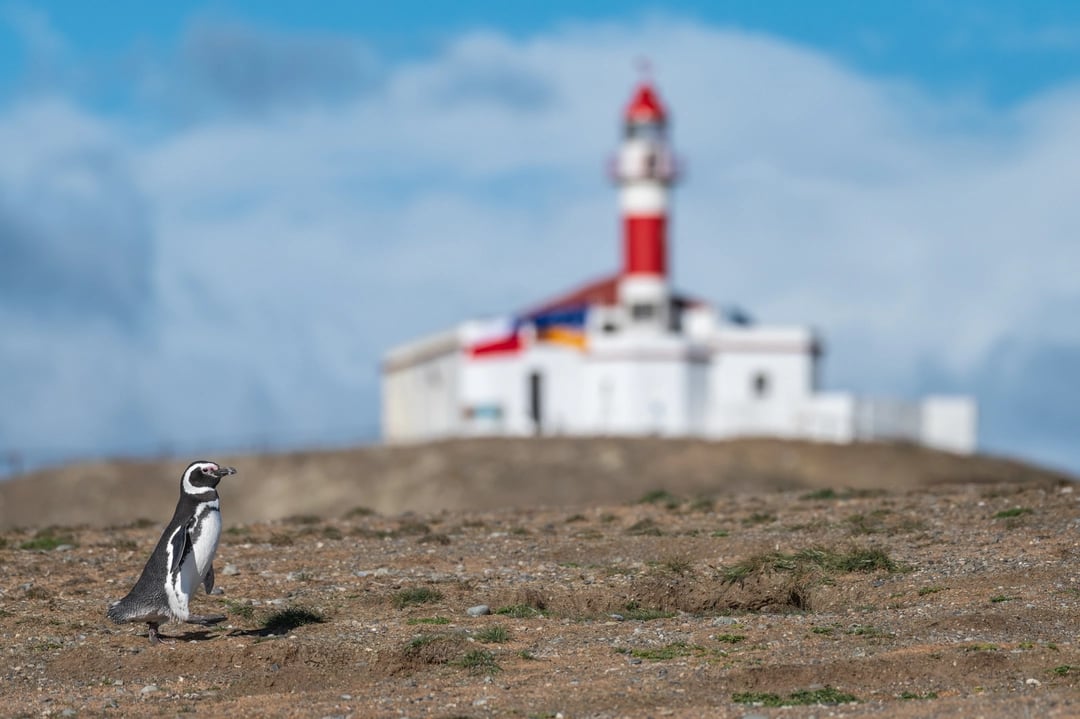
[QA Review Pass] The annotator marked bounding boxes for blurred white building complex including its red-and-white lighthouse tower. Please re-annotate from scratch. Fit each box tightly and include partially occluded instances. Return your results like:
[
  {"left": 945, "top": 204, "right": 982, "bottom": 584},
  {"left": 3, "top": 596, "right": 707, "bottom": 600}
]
[{"left": 382, "top": 83, "right": 976, "bottom": 453}]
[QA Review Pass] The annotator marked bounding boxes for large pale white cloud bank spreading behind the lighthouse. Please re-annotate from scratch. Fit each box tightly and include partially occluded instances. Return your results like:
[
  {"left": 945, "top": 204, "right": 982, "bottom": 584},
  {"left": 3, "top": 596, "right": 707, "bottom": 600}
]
[{"left": 0, "top": 19, "right": 1080, "bottom": 466}]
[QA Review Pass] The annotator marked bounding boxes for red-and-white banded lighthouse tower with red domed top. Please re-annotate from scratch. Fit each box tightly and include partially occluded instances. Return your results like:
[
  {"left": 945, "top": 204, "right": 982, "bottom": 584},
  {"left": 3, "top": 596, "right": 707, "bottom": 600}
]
[{"left": 613, "top": 81, "right": 676, "bottom": 334}]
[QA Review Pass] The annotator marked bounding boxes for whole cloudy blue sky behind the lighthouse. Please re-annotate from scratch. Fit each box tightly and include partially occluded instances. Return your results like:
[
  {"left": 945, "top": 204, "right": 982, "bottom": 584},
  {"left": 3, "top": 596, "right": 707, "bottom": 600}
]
[{"left": 0, "top": 0, "right": 1080, "bottom": 472}]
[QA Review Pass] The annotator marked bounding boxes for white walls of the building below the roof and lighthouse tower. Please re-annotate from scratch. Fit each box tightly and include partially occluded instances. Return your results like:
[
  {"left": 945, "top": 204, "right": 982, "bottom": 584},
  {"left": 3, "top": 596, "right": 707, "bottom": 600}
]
[{"left": 382, "top": 323, "right": 977, "bottom": 453}]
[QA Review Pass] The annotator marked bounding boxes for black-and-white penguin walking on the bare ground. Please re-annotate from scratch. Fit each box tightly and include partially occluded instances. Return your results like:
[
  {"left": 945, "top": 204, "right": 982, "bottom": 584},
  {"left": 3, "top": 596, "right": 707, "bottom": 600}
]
[{"left": 107, "top": 461, "right": 237, "bottom": 645}]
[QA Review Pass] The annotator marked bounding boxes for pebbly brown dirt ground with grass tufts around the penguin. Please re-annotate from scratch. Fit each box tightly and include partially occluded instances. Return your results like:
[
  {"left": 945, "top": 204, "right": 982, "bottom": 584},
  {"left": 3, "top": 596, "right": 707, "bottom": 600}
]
[{"left": 0, "top": 453, "right": 1080, "bottom": 719}]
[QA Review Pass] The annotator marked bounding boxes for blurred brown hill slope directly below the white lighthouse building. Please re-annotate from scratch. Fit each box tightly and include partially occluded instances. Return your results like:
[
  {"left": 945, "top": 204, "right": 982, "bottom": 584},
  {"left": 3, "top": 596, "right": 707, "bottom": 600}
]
[{"left": 0, "top": 438, "right": 1068, "bottom": 528}]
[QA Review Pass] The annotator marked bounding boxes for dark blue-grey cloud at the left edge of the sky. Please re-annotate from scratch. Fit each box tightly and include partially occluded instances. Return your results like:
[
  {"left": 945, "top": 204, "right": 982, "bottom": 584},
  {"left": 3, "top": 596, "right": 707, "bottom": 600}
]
[{"left": 0, "top": 100, "right": 154, "bottom": 331}]
